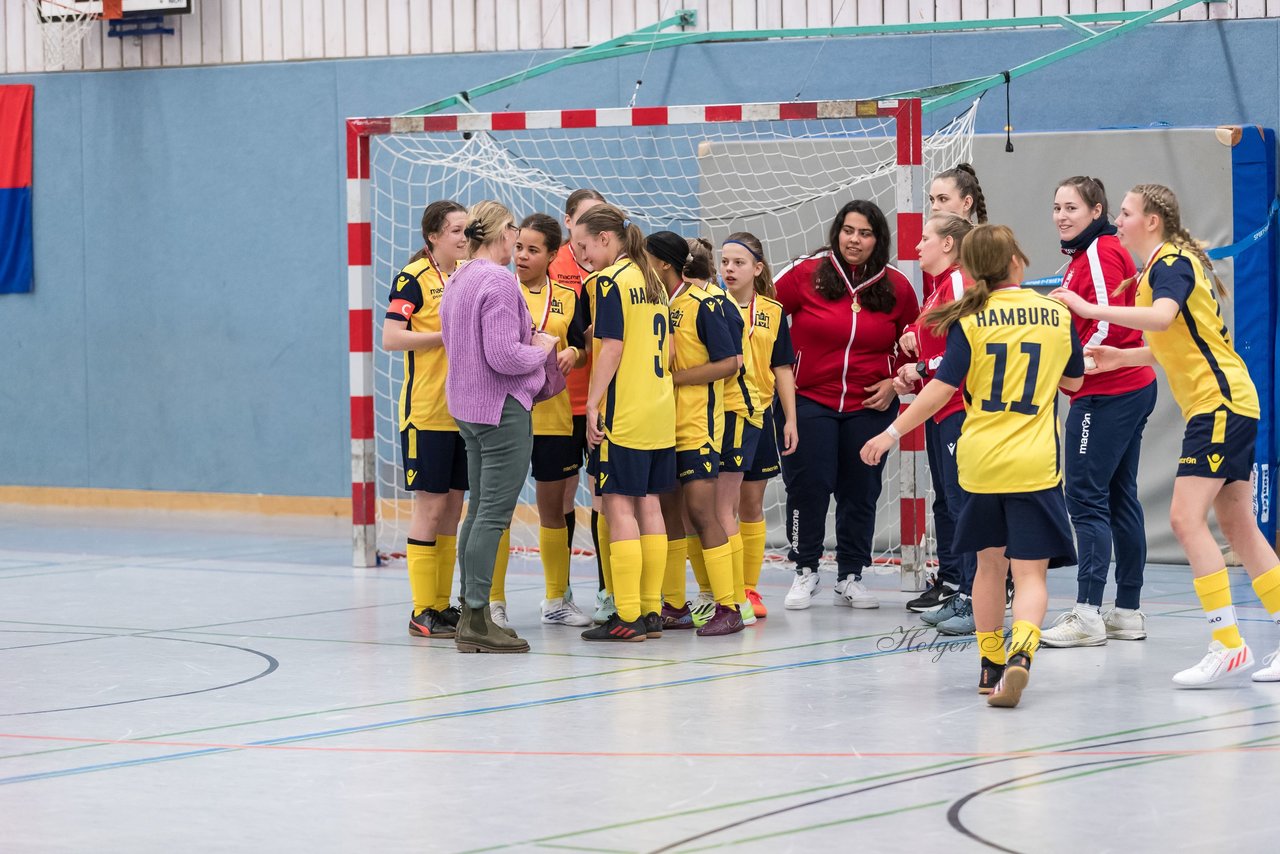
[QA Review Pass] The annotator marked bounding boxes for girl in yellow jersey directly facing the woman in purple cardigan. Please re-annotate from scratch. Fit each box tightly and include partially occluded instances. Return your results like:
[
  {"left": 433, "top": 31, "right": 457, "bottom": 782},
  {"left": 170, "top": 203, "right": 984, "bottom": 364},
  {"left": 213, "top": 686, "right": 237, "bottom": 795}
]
[{"left": 489, "top": 214, "right": 591, "bottom": 627}]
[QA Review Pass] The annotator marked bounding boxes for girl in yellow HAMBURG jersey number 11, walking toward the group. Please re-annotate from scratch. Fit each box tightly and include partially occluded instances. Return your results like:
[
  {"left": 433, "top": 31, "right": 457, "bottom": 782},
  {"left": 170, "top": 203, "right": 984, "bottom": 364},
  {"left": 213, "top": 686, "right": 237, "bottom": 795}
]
[{"left": 861, "top": 225, "right": 1084, "bottom": 707}]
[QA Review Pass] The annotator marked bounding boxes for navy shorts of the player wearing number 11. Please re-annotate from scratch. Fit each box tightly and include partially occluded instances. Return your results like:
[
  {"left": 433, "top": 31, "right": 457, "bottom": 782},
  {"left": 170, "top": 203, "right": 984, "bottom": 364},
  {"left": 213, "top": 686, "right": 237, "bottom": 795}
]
[{"left": 952, "top": 484, "right": 1075, "bottom": 568}]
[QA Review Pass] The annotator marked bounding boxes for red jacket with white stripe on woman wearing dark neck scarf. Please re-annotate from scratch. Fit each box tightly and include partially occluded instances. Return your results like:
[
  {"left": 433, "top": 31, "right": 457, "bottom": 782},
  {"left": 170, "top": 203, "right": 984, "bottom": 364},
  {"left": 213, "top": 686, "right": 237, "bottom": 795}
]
[{"left": 1062, "top": 234, "right": 1156, "bottom": 399}]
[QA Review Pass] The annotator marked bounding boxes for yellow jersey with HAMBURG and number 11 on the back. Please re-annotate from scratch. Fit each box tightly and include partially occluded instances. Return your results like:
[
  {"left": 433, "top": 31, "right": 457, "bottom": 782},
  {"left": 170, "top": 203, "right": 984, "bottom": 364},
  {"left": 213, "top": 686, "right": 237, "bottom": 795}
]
[{"left": 937, "top": 287, "right": 1084, "bottom": 494}]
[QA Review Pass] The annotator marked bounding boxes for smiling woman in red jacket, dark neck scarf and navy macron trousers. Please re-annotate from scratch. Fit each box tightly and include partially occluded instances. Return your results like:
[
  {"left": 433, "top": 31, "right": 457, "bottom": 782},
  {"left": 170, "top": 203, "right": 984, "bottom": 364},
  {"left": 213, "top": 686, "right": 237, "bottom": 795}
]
[{"left": 1041, "top": 175, "right": 1156, "bottom": 647}]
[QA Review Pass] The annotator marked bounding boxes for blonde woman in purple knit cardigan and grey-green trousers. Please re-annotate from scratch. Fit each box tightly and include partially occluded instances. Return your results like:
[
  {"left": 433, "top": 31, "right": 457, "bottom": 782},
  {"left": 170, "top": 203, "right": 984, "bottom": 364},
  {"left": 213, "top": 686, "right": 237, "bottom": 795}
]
[{"left": 440, "top": 201, "right": 556, "bottom": 653}]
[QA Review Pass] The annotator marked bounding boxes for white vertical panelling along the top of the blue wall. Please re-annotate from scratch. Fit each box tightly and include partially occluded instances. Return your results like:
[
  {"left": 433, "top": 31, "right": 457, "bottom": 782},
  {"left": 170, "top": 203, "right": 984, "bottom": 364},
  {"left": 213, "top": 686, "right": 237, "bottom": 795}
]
[{"left": 0, "top": 0, "right": 1280, "bottom": 73}]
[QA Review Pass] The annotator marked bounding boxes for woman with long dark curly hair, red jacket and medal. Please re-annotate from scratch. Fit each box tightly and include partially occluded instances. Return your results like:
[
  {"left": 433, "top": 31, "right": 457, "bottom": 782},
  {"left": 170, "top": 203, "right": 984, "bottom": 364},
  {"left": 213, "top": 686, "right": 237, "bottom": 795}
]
[{"left": 776, "top": 200, "right": 919, "bottom": 609}]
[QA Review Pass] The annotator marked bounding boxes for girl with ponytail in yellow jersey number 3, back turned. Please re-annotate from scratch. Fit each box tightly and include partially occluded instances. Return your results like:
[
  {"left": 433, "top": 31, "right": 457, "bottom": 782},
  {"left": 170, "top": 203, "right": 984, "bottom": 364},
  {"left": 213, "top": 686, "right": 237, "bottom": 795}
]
[{"left": 572, "top": 205, "right": 676, "bottom": 641}]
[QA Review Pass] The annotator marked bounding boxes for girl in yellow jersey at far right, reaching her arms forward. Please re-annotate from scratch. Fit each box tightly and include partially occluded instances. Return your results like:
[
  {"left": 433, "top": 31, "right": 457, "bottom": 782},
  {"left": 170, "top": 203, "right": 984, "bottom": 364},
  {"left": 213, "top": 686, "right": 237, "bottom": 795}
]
[{"left": 1051, "top": 184, "right": 1280, "bottom": 688}]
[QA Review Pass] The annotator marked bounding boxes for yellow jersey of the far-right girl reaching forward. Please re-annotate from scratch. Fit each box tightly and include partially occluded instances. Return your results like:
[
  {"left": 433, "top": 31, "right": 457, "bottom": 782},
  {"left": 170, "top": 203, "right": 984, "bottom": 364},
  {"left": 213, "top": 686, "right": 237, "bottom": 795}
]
[{"left": 1134, "top": 243, "right": 1260, "bottom": 421}]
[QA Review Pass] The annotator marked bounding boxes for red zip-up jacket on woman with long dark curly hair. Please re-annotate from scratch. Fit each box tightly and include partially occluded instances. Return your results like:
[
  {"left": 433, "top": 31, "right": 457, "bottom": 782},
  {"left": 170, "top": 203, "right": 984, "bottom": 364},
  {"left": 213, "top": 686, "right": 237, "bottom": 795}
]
[{"left": 776, "top": 252, "right": 920, "bottom": 412}]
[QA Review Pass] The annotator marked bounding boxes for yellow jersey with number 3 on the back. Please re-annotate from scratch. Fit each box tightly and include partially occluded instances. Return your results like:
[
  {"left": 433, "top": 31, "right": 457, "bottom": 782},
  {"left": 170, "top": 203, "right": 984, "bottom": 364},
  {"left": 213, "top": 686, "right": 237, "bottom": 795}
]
[{"left": 593, "top": 259, "right": 676, "bottom": 451}]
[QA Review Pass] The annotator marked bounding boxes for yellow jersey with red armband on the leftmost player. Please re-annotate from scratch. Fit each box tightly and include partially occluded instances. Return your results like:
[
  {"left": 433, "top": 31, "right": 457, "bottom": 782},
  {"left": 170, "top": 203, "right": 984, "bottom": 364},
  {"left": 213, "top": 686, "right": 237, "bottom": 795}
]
[{"left": 387, "top": 257, "right": 458, "bottom": 430}]
